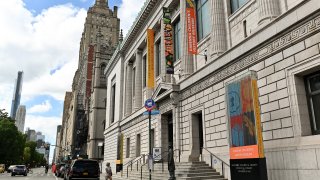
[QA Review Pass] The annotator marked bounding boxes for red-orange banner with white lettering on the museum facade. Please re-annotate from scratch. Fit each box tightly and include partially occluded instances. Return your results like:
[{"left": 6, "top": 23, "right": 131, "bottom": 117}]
[{"left": 186, "top": 0, "right": 198, "bottom": 54}]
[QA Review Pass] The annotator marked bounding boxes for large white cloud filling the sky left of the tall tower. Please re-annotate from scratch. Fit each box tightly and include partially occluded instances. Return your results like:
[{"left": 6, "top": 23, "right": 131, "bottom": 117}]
[{"left": 0, "top": 0, "right": 86, "bottom": 112}]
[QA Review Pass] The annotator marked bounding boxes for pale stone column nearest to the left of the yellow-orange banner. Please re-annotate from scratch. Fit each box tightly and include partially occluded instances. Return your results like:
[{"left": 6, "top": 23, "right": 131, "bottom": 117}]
[{"left": 134, "top": 49, "right": 142, "bottom": 109}]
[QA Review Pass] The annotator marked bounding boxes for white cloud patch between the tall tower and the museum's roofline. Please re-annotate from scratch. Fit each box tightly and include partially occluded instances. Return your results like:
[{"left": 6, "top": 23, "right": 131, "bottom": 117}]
[{"left": 118, "top": 0, "right": 146, "bottom": 35}]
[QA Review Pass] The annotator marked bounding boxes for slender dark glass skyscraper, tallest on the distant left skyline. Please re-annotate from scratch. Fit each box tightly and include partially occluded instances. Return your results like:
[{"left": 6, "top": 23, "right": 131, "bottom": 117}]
[{"left": 10, "top": 71, "right": 23, "bottom": 119}]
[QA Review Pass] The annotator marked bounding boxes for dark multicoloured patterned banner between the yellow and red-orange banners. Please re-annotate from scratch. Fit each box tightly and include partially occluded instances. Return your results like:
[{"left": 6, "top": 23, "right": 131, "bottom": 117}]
[{"left": 163, "top": 7, "right": 174, "bottom": 74}]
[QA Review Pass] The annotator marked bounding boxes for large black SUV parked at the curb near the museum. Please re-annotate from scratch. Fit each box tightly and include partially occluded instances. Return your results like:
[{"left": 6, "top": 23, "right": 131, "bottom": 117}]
[{"left": 65, "top": 159, "right": 100, "bottom": 180}]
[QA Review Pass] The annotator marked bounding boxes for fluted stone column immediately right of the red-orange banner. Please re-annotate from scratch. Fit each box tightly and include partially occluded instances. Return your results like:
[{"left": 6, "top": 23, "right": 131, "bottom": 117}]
[{"left": 211, "top": 0, "right": 227, "bottom": 57}]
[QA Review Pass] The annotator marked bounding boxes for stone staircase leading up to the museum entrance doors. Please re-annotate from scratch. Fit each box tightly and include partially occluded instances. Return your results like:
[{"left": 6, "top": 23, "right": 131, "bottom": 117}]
[{"left": 112, "top": 162, "right": 227, "bottom": 180}]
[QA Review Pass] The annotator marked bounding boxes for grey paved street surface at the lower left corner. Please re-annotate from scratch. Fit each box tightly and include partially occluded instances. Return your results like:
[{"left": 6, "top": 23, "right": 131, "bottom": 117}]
[{"left": 0, "top": 168, "right": 57, "bottom": 180}]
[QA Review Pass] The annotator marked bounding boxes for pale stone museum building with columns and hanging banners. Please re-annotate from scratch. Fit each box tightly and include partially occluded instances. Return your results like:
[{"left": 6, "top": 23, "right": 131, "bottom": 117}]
[{"left": 90, "top": 0, "right": 320, "bottom": 180}]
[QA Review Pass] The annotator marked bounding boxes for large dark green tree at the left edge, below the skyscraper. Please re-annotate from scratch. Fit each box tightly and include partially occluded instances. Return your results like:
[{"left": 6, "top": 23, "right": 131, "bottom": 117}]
[{"left": 0, "top": 109, "right": 26, "bottom": 165}]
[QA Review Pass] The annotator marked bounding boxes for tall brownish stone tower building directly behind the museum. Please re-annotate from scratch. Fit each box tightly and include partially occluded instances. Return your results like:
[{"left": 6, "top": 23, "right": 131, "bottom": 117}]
[{"left": 74, "top": 0, "right": 120, "bottom": 159}]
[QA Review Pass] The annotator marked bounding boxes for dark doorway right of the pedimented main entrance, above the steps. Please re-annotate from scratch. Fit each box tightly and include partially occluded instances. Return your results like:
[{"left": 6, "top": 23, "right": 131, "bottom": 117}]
[{"left": 189, "top": 112, "right": 204, "bottom": 161}]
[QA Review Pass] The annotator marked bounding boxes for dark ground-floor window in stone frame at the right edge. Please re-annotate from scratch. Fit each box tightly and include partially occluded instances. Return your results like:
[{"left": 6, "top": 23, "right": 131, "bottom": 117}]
[{"left": 305, "top": 72, "right": 320, "bottom": 134}]
